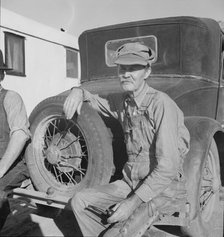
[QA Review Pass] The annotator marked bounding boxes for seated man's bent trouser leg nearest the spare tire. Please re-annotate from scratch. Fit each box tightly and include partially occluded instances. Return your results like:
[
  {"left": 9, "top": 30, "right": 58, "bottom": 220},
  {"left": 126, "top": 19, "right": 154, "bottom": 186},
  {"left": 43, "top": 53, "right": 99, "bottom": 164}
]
[{"left": 71, "top": 180, "right": 132, "bottom": 237}]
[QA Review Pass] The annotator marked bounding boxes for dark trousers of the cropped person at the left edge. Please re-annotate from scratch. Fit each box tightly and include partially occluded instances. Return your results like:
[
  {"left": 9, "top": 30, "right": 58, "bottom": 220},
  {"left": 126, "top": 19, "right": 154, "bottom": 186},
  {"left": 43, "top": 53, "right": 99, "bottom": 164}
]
[{"left": 0, "top": 160, "right": 29, "bottom": 230}]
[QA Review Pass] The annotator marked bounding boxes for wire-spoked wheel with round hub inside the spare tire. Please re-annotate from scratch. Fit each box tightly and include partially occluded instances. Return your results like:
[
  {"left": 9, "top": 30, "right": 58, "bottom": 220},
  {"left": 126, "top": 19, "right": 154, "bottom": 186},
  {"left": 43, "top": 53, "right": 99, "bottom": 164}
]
[{"left": 33, "top": 116, "right": 88, "bottom": 187}]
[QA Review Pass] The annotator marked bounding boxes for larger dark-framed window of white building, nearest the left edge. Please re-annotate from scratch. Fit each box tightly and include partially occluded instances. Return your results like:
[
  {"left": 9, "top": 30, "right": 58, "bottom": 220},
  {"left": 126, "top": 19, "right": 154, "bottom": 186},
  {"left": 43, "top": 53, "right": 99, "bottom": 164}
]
[{"left": 4, "top": 32, "right": 26, "bottom": 76}]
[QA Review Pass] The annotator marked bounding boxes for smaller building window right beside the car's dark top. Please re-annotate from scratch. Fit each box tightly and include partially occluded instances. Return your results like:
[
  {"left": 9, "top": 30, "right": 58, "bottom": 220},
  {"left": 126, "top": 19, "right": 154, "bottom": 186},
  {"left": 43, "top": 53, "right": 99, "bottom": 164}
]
[{"left": 66, "top": 48, "right": 78, "bottom": 78}]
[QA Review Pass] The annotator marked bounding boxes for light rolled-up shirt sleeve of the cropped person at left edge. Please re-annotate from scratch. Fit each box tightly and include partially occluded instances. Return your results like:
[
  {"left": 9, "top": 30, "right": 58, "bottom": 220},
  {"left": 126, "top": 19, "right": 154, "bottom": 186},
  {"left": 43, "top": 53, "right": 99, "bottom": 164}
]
[{"left": 4, "top": 91, "right": 31, "bottom": 139}]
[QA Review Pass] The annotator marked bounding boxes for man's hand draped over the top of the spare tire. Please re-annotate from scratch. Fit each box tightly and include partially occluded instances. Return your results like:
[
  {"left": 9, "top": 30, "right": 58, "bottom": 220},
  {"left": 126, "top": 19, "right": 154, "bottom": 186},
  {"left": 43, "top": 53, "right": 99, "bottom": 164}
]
[{"left": 63, "top": 87, "right": 83, "bottom": 119}]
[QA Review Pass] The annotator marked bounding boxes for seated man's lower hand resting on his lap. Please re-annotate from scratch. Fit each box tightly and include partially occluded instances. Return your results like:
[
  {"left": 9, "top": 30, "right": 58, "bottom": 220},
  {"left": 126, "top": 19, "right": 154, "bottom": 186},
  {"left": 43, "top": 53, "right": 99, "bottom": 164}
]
[{"left": 107, "top": 194, "right": 142, "bottom": 223}]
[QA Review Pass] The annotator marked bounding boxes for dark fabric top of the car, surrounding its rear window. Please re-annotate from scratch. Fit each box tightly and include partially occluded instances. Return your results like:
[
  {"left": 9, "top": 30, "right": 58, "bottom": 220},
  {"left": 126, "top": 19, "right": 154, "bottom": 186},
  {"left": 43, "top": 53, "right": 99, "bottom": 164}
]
[{"left": 79, "top": 16, "right": 222, "bottom": 81}]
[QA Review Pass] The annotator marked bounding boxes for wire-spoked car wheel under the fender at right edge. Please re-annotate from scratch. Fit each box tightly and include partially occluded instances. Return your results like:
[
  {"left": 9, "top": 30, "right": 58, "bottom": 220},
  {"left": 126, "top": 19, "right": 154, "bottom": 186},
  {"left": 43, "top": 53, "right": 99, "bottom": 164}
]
[{"left": 182, "top": 139, "right": 223, "bottom": 237}]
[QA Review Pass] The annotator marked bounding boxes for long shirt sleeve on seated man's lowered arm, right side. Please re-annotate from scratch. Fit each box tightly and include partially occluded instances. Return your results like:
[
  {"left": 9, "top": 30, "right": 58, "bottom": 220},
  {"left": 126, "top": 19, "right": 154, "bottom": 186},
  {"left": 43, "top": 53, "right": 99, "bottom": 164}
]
[{"left": 135, "top": 92, "right": 189, "bottom": 202}]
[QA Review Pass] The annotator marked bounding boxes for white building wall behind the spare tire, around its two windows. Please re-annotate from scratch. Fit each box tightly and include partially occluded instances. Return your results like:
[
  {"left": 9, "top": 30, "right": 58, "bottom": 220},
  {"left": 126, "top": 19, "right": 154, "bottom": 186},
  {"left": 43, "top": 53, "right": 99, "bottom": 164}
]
[{"left": 0, "top": 9, "right": 79, "bottom": 115}]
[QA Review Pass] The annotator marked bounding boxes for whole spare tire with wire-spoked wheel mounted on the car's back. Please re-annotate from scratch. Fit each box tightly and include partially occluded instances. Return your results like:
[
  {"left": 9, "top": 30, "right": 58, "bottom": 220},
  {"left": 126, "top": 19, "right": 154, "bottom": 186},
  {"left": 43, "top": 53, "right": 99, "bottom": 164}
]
[{"left": 25, "top": 96, "right": 113, "bottom": 197}]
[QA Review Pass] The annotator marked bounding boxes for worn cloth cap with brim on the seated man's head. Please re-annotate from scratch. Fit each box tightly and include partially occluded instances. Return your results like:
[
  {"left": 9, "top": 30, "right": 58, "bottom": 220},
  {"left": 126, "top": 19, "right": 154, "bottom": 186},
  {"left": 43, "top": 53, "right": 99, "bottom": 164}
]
[{"left": 114, "top": 42, "right": 155, "bottom": 66}]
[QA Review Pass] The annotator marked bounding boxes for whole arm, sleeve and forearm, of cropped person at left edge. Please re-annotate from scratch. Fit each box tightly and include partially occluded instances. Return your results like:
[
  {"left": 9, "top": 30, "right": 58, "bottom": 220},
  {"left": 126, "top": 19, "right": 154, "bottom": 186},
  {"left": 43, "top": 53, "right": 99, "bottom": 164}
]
[{"left": 0, "top": 91, "right": 31, "bottom": 178}]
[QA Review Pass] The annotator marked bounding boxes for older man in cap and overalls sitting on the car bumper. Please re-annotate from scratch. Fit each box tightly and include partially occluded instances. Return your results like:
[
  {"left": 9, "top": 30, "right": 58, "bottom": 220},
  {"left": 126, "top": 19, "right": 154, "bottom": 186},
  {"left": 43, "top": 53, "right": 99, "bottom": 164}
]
[{"left": 64, "top": 42, "right": 190, "bottom": 237}]
